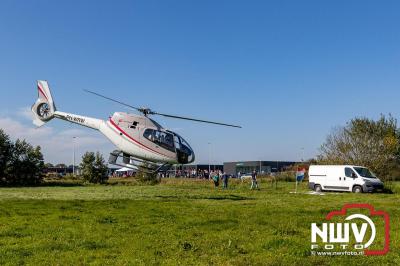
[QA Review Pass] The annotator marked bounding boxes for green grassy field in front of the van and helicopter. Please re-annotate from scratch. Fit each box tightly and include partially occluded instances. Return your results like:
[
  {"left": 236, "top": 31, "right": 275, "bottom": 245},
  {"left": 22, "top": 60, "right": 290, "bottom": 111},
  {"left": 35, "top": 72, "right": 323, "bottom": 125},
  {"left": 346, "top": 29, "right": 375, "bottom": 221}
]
[{"left": 0, "top": 180, "right": 400, "bottom": 265}]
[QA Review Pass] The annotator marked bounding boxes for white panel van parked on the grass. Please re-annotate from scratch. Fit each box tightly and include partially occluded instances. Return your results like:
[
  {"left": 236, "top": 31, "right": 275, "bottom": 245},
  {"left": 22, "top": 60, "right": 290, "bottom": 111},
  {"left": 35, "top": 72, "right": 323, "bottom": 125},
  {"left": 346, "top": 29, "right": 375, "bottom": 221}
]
[{"left": 308, "top": 165, "right": 383, "bottom": 193}]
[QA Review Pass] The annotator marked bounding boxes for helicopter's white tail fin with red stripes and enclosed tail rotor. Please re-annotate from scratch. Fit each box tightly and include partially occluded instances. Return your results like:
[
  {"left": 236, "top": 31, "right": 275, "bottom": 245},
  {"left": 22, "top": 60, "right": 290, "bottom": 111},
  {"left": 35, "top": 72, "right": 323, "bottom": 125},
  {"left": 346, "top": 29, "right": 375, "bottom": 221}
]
[{"left": 31, "top": 80, "right": 56, "bottom": 127}]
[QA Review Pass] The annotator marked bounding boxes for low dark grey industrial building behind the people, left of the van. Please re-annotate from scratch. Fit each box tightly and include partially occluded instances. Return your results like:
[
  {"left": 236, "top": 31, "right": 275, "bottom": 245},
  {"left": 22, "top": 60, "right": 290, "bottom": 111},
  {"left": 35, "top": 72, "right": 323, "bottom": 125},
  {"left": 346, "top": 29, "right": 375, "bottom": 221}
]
[{"left": 224, "top": 161, "right": 298, "bottom": 176}]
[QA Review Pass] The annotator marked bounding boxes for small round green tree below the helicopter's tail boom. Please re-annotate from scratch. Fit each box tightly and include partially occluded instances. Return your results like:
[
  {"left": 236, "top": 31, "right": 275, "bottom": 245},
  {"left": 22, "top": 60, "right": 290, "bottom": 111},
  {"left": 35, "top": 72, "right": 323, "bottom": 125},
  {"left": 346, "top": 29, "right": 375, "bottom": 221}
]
[{"left": 80, "top": 152, "right": 108, "bottom": 183}]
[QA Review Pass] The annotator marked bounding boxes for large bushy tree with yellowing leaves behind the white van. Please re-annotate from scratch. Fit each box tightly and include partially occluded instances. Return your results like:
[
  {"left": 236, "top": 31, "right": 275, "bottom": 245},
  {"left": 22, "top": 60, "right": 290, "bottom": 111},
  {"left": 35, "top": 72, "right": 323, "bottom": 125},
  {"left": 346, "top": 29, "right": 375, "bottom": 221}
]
[{"left": 318, "top": 115, "right": 400, "bottom": 179}]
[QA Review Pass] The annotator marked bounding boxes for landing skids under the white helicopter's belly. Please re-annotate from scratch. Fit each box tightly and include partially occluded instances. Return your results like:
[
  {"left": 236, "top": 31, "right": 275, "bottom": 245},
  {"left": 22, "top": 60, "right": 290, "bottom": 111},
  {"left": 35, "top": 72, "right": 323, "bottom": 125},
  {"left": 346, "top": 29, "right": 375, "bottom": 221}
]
[{"left": 108, "top": 150, "right": 172, "bottom": 174}]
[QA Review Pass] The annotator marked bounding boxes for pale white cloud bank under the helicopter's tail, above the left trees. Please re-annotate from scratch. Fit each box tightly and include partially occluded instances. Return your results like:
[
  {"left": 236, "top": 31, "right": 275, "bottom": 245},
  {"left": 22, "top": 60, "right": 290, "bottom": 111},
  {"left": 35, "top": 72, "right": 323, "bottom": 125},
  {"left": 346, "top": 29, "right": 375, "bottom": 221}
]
[{"left": 0, "top": 116, "right": 114, "bottom": 165}]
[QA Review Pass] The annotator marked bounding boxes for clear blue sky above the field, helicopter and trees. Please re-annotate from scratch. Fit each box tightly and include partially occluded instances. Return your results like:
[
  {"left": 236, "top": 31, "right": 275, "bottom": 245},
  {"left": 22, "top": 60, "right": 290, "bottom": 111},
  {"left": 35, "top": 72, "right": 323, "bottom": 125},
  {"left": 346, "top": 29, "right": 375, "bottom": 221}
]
[{"left": 0, "top": 0, "right": 400, "bottom": 164}]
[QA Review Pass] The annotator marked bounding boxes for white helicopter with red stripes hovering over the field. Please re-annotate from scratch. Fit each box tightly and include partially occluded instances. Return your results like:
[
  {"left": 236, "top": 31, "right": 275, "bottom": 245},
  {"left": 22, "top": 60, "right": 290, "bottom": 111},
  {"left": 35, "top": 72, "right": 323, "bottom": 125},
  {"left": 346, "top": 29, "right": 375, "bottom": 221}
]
[{"left": 31, "top": 80, "right": 241, "bottom": 172}]
